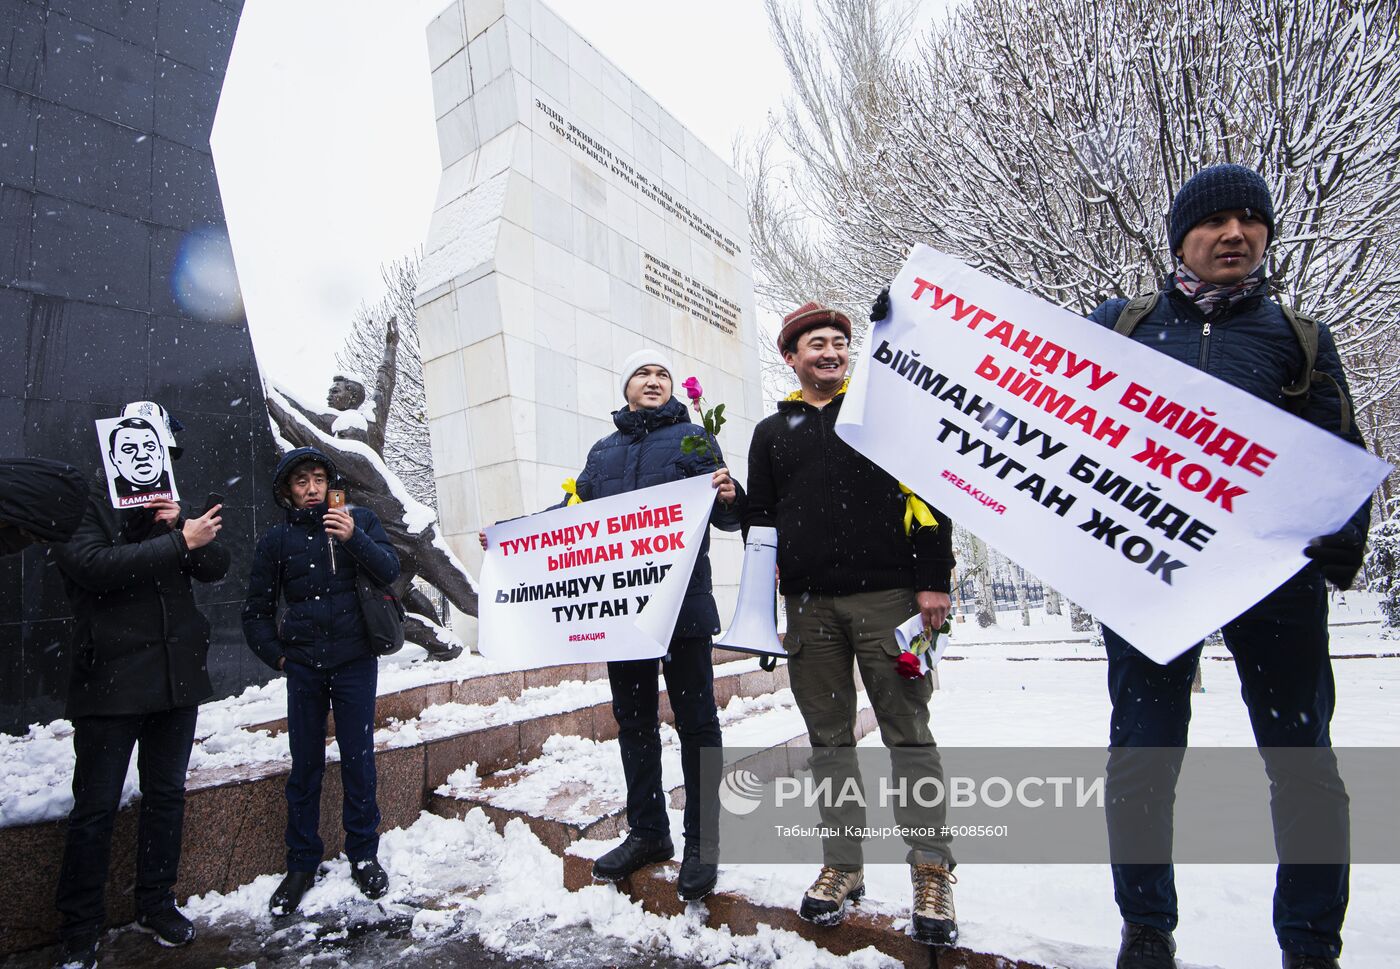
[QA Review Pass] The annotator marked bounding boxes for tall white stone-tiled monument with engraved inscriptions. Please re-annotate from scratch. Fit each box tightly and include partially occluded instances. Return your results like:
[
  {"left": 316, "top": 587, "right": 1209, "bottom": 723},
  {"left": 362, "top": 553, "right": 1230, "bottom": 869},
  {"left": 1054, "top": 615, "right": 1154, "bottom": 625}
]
[{"left": 417, "top": 0, "right": 762, "bottom": 622}]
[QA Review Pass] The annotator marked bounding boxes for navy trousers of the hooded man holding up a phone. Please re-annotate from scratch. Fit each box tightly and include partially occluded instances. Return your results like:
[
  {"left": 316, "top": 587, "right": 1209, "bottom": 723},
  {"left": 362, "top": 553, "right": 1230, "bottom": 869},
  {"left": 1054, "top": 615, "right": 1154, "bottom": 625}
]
[{"left": 286, "top": 653, "right": 379, "bottom": 871}]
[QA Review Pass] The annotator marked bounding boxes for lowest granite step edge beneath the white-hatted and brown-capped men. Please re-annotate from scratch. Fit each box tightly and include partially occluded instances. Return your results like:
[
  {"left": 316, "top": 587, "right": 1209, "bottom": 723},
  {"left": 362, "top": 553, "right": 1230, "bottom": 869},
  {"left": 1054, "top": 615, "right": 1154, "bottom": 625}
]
[{"left": 564, "top": 842, "right": 1044, "bottom": 969}]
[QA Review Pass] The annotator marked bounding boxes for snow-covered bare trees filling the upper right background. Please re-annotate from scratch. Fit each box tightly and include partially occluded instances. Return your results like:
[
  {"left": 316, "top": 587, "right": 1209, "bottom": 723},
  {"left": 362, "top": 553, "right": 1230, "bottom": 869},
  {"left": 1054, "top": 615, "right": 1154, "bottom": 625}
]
[{"left": 750, "top": 0, "right": 1400, "bottom": 449}]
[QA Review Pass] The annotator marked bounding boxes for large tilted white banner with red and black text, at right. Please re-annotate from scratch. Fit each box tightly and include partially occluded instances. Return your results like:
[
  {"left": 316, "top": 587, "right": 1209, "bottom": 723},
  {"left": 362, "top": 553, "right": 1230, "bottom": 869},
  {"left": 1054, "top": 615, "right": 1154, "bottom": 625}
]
[{"left": 836, "top": 245, "right": 1390, "bottom": 662}]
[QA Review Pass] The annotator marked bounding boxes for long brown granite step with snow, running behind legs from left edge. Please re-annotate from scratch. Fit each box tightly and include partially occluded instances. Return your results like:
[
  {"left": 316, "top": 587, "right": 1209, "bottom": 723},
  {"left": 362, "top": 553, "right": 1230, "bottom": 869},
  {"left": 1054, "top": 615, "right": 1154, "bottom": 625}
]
[{"left": 0, "top": 650, "right": 787, "bottom": 956}]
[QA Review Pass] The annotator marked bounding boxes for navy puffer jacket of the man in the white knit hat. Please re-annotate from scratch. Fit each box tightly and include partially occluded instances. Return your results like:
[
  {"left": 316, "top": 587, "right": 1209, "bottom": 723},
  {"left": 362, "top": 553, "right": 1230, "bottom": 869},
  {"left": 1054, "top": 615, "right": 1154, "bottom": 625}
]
[{"left": 578, "top": 398, "right": 748, "bottom": 637}]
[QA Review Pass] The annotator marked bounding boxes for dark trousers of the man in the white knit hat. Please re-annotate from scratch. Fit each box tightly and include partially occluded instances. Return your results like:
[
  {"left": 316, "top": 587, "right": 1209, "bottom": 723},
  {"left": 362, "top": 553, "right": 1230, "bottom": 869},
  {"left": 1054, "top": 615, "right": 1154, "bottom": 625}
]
[{"left": 608, "top": 636, "right": 722, "bottom": 845}]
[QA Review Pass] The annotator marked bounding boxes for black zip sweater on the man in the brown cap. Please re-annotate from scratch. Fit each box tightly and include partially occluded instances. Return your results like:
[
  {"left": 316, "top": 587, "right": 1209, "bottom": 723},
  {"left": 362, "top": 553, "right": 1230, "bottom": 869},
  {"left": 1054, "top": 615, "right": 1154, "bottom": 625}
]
[{"left": 745, "top": 395, "right": 953, "bottom": 595}]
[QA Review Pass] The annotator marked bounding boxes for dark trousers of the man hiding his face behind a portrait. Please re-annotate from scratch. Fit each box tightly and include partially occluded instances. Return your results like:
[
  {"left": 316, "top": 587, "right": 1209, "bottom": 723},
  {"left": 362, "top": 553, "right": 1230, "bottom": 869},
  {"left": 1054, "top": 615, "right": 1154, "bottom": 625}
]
[{"left": 57, "top": 707, "right": 199, "bottom": 940}]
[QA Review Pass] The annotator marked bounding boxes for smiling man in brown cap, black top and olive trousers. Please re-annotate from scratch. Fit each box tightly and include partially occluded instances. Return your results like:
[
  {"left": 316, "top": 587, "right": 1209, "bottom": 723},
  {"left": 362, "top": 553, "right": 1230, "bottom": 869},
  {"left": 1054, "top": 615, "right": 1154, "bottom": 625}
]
[{"left": 745, "top": 302, "right": 958, "bottom": 944}]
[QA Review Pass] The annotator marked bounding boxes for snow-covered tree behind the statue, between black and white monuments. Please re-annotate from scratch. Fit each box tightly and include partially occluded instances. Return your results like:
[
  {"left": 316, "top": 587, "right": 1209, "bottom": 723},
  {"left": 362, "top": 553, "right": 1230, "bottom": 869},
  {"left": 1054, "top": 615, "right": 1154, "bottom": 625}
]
[{"left": 336, "top": 255, "right": 437, "bottom": 508}]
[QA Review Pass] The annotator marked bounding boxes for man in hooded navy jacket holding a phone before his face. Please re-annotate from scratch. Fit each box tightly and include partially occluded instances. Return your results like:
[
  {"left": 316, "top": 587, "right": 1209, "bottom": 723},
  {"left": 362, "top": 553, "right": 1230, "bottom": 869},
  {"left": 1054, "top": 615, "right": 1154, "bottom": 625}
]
[{"left": 244, "top": 448, "right": 399, "bottom": 916}]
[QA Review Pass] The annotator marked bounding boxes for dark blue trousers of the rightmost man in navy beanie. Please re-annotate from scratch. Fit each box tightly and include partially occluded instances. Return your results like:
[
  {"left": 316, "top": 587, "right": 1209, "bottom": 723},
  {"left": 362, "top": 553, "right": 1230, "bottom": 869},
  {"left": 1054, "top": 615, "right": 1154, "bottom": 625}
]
[{"left": 1103, "top": 566, "right": 1350, "bottom": 956}]
